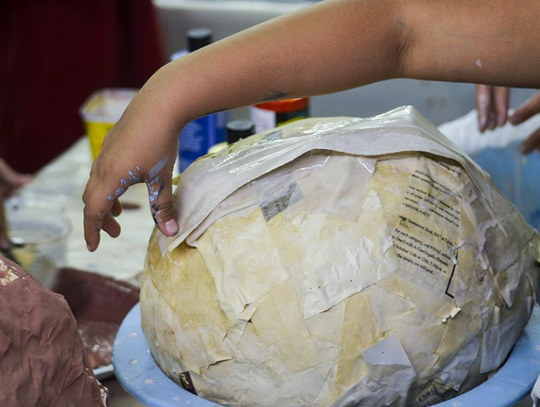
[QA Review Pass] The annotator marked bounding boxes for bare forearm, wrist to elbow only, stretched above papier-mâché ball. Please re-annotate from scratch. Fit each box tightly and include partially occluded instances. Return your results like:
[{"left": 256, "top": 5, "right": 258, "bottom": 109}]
[{"left": 134, "top": 0, "right": 400, "bottom": 129}]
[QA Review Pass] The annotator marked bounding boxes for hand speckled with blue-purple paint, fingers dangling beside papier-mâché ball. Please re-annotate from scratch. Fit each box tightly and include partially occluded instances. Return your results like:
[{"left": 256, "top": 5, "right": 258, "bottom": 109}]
[{"left": 83, "top": 88, "right": 178, "bottom": 251}]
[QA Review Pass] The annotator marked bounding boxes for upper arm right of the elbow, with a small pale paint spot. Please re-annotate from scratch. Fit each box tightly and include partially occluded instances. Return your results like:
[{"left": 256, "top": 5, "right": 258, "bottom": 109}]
[{"left": 401, "top": 0, "right": 540, "bottom": 88}]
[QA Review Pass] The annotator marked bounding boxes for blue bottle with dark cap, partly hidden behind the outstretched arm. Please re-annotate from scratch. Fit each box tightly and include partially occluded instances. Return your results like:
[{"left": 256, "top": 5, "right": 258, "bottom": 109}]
[{"left": 175, "top": 28, "right": 230, "bottom": 172}]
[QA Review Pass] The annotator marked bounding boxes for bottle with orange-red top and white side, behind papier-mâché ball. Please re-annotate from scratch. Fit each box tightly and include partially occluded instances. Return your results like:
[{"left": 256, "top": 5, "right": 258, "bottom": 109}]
[{"left": 249, "top": 98, "right": 309, "bottom": 133}]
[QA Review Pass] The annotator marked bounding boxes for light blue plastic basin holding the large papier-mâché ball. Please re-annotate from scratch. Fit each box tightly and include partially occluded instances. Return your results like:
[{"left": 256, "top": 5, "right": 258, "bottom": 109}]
[{"left": 113, "top": 304, "right": 540, "bottom": 407}]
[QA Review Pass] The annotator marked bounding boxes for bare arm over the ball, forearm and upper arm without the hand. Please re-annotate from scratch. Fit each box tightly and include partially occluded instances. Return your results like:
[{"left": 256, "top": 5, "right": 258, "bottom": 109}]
[{"left": 127, "top": 0, "right": 540, "bottom": 132}]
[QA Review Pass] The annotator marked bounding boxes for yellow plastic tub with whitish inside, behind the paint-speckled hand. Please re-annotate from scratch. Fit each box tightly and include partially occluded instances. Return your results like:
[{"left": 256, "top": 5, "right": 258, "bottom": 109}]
[{"left": 79, "top": 89, "right": 139, "bottom": 160}]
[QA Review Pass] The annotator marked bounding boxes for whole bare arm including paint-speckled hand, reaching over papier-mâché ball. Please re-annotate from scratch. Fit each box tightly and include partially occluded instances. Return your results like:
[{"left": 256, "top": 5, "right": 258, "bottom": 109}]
[{"left": 83, "top": 0, "right": 540, "bottom": 250}]
